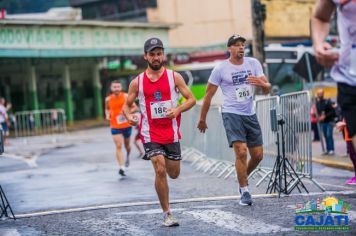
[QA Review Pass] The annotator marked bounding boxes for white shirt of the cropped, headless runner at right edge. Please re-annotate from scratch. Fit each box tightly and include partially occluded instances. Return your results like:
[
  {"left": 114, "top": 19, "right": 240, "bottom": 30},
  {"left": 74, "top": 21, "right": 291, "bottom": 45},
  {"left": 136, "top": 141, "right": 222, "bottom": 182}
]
[{"left": 331, "top": 0, "right": 356, "bottom": 86}]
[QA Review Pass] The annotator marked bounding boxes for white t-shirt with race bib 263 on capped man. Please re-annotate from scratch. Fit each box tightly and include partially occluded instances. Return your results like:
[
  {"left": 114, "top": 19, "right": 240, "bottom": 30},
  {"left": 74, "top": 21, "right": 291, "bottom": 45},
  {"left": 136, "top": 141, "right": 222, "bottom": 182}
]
[{"left": 208, "top": 57, "right": 264, "bottom": 115}]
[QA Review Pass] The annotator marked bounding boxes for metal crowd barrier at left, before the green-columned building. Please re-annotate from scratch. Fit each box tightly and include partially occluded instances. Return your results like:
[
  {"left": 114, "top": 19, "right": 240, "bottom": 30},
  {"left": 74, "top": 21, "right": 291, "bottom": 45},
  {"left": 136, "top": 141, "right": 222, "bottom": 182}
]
[{"left": 14, "top": 109, "right": 67, "bottom": 137}]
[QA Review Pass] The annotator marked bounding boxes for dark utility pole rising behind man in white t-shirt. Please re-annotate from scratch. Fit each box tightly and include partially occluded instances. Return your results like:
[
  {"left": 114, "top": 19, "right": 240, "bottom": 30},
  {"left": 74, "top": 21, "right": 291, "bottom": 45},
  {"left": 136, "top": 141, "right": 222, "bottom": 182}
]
[{"left": 251, "top": 0, "right": 266, "bottom": 65}]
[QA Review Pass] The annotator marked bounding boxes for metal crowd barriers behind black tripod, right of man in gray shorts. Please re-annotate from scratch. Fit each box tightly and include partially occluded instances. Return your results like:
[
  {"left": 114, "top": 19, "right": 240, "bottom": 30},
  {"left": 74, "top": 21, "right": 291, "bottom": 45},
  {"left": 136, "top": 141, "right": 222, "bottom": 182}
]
[{"left": 249, "top": 91, "right": 325, "bottom": 191}]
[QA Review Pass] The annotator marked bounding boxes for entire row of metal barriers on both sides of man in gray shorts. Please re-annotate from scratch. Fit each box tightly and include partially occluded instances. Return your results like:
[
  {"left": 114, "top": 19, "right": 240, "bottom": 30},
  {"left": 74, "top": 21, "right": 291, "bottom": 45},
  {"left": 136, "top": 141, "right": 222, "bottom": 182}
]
[{"left": 181, "top": 91, "right": 324, "bottom": 190}]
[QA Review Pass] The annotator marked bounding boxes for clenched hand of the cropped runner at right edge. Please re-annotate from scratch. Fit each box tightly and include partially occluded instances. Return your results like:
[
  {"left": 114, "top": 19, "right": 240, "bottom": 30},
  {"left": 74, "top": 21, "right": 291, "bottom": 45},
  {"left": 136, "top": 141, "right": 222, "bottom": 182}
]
[{"left": 315, "top": 42, "right": 339, "bottom": 67}]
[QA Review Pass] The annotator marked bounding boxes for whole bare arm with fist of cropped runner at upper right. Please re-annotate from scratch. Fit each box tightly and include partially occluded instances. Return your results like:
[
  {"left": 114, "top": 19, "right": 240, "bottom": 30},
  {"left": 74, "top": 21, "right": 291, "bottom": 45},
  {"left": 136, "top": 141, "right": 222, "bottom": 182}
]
[{"left": 311, "top": 0, "right": 339, "bottom": 67}]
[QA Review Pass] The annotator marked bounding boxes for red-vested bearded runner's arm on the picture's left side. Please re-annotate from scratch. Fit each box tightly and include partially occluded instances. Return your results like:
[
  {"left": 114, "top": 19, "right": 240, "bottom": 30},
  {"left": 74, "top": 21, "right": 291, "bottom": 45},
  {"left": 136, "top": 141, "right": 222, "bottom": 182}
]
[{"left": 123, "top": 77, "right": 138, "bottom": 125}]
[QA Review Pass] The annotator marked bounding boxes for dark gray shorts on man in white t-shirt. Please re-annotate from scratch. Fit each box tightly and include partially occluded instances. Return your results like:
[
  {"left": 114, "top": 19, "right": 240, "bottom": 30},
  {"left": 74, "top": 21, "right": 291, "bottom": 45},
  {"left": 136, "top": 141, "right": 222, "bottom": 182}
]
[{"left": 222, "top": 113, "right": 263, "bottom": 147}]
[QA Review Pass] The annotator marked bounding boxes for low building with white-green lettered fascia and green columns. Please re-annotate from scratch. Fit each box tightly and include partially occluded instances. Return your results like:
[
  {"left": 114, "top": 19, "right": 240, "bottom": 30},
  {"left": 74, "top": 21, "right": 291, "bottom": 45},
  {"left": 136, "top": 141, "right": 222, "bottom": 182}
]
[{"left": 0, "top": 20, "right": 169, "bottom": 122}]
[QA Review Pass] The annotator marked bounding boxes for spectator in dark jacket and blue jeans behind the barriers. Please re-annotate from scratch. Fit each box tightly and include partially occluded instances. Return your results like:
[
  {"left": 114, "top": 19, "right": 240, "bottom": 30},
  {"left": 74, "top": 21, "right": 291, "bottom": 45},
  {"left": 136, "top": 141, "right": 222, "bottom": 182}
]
[{"left": 316, "top": 89, "right": 336, "bottom": 155}]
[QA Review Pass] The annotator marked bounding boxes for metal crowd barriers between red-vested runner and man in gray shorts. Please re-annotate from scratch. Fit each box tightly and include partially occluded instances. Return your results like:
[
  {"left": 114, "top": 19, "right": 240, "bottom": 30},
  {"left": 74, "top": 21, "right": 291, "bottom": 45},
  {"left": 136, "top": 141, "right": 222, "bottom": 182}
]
[{"left": 181, "top": 105, "right": 235, "bottom": 179}]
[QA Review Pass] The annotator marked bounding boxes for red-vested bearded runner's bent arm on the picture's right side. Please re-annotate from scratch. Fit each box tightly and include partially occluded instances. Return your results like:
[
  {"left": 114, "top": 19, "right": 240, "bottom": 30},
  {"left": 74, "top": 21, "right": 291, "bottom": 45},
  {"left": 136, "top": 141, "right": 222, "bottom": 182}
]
[{"left": 166, "top": 72, "right": 196, "bottom": 119}]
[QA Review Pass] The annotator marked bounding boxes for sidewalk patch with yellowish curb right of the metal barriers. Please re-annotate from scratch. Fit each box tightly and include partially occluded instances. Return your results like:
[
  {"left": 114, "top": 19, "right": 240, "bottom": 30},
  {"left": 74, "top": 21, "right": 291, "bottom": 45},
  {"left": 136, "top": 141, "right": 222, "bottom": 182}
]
[{"left": 312, "top": 132, "right": 354, "bottom": 171}]
